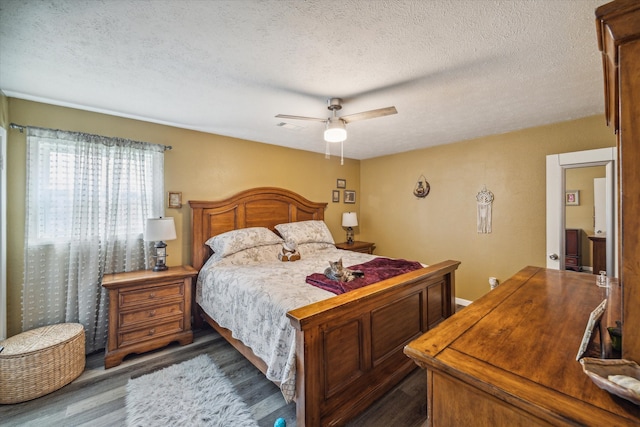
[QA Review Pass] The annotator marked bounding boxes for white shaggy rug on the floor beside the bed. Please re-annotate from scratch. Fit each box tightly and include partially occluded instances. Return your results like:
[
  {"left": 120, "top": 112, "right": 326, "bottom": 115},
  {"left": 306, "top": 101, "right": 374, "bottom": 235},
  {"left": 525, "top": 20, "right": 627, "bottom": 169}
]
[{"left": 126, "top": 354, "right": 258, "bottom": 427}]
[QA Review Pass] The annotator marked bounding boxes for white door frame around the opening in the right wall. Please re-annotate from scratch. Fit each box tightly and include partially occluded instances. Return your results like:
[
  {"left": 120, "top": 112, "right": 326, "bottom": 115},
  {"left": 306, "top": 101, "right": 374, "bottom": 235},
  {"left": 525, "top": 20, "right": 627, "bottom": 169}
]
[{"left": 546, "top": 147, "right": 618, "bottom": 277}]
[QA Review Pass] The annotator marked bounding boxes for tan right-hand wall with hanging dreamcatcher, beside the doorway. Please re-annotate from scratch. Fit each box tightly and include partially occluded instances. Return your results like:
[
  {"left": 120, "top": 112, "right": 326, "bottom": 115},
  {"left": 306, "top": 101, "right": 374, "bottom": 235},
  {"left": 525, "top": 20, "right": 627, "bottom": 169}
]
[{"left": 359, "top": 116, "right": 615, "bottom": 300}]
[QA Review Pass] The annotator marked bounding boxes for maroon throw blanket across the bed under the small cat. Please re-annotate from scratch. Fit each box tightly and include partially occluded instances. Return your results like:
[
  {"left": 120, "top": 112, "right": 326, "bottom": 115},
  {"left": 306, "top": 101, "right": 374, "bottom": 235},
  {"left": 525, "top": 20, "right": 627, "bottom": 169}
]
[{"left": 307, "top": 257, "right": 422, "bottom": 295}]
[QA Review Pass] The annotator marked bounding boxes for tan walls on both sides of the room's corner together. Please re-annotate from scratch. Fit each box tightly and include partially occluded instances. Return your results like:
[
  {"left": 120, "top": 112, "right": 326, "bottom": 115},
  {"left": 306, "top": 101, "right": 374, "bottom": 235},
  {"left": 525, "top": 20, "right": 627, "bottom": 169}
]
[{"left": 7, "top": 98, "right": 615, "bottom": 335}]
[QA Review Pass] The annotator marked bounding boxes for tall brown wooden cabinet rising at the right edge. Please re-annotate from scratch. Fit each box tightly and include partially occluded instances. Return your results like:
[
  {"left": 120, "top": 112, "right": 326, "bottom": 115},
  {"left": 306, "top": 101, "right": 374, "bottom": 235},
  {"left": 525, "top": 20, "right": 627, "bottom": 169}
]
[{"left": 596, "top": 0, "right": 640, "bottom": 363}]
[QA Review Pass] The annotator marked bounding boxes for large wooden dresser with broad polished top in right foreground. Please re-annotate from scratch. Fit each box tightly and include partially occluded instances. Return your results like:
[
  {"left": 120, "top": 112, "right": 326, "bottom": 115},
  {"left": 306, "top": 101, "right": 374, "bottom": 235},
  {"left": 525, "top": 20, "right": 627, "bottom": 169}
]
[{"left": 405, "top": 267, "right": 640, "bottom": 427}]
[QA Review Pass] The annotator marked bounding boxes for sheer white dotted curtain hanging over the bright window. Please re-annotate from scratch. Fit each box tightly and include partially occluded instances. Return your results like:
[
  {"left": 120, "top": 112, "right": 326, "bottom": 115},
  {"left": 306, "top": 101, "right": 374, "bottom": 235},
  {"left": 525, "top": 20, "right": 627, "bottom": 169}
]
[{"left": 22, "top": 127, "right": 165, "bottom": 353}]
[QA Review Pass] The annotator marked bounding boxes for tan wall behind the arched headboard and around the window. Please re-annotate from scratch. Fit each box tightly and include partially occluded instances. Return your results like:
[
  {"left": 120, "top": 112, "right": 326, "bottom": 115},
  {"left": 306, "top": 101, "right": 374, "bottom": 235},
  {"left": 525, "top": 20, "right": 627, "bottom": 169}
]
[{"left": 7, "top": 98, "right": 360, "bottom": 335}]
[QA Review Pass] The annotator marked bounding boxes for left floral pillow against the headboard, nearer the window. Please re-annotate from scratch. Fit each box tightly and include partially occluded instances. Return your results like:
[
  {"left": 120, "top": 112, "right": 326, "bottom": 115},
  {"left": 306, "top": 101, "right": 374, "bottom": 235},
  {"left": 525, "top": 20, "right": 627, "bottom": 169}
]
[{"left": 205, "top": 227, "right": 282, "bottom": 259}]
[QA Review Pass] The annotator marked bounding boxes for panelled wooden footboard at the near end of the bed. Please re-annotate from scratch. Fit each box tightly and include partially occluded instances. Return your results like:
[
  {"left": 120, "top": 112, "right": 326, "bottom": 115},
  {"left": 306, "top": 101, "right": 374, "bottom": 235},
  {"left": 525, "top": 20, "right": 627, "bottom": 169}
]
[{"left": 287, "top": 261, "right": 460, "bottom": 426}]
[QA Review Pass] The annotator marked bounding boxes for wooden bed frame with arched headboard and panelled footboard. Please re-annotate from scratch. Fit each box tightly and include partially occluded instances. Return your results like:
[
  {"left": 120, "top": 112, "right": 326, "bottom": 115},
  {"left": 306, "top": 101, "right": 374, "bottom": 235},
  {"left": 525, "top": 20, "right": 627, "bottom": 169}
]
[{"left": 189, "top": 187, "right": 460, "bottom": 426}]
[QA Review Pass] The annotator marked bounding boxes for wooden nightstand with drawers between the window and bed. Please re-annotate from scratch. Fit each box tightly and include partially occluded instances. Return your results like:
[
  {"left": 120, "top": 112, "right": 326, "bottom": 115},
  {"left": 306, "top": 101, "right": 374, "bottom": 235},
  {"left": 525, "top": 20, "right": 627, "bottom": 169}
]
[{"left": 102, "top": 266, "right": 198, "bottom": 369}]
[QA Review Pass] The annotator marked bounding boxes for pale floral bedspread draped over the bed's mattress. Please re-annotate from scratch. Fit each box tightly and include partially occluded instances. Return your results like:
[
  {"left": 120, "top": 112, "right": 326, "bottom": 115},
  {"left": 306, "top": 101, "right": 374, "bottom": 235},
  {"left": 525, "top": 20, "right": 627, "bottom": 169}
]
[{"left": 196, "top": 244, "right": 375, "bottom": 402}]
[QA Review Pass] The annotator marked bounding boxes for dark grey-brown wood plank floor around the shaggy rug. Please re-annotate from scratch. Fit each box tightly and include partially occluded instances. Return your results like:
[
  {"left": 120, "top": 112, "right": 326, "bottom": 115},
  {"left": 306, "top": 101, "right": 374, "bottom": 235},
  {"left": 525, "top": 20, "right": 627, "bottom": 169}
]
[{"left": 0, "top": 327, "right": 426, "bottom": 427}]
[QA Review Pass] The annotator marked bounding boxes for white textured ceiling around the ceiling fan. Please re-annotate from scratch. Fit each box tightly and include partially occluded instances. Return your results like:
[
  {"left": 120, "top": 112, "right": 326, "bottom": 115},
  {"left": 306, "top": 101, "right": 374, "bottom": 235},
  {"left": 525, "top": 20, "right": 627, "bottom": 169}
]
[{"left": 0, "top": 0, "right": 606, "bottom": 159}]
